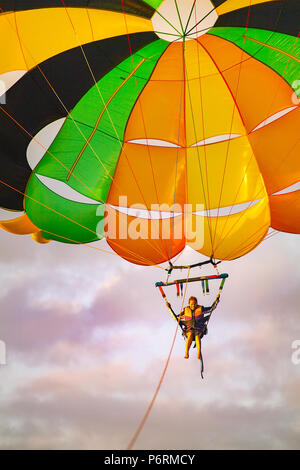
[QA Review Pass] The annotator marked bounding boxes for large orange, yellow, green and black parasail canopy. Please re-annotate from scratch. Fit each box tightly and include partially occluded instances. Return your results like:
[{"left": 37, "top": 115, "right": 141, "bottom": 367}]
[{"left": 0, "top": 0, "right": 300, "bottom": 265}]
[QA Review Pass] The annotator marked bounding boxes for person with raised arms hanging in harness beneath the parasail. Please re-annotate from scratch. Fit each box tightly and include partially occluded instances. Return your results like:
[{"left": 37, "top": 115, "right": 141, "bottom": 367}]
[{"left": 166, "top": 294, "right": 220, "bottom": 359}]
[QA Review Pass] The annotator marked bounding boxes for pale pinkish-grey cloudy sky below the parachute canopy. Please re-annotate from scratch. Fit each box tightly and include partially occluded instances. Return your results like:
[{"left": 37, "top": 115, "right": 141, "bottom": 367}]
[{"left": 0, "top": 221, "right": 300, "bottom": 450}]
